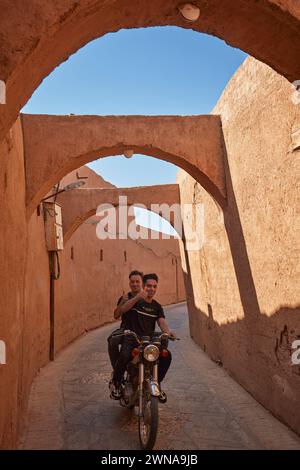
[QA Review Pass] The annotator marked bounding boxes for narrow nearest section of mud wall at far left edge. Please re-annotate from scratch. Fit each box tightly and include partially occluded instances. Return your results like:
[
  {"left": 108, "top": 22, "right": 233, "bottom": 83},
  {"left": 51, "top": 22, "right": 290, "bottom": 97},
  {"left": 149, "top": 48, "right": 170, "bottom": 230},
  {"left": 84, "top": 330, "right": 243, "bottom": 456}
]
[{"left": 0, "top": 120, "right": 26, "bottom": 447}]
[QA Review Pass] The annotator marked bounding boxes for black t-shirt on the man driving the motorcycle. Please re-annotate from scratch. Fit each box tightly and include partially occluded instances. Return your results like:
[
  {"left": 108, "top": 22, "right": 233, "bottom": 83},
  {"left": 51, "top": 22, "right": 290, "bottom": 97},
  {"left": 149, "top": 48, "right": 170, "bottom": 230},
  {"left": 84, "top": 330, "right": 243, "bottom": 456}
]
[{"left": 126, "top": 300, "right": 165, "bottom": 337}]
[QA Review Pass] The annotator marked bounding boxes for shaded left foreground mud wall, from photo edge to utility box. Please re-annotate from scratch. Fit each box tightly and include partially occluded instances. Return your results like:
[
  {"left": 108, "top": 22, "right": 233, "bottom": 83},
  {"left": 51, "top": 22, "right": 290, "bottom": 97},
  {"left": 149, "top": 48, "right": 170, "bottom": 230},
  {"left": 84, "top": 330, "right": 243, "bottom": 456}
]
[{"left": 0, "top": 114, "right": 49, "bottom": 449}]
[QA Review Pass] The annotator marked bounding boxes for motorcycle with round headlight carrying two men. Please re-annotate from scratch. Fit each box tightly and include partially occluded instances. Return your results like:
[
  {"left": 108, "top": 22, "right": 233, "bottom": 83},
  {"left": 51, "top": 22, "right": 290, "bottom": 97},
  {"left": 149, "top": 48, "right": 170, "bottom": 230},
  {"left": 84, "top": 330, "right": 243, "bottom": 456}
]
[{"left": 120, "top": 330, "right": 179, "bottom": 450}]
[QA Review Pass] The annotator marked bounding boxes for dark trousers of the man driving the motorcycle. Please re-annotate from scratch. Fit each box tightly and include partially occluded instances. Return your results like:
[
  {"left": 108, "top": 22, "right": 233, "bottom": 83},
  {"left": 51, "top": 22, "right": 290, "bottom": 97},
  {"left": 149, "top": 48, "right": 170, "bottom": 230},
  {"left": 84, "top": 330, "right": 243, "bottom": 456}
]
[{"left": 114, "top": 336, "right": 172, "bottom": 383}]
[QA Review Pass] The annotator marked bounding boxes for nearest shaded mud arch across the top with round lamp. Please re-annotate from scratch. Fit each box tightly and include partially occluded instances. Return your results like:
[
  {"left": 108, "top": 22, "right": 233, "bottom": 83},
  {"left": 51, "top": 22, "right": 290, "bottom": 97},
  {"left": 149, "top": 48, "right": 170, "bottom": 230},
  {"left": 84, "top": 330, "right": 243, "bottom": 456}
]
[{"left": 0, "top": 0, "right": 300, "bottom": 139}]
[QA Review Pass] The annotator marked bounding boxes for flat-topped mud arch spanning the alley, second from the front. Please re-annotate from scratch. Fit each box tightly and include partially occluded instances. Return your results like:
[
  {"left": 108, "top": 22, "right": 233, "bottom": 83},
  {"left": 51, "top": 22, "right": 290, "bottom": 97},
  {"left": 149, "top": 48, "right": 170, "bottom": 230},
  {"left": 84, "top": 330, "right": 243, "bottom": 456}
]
[{"left": 22, "top": 114, "right": 226, "bottom": 216}]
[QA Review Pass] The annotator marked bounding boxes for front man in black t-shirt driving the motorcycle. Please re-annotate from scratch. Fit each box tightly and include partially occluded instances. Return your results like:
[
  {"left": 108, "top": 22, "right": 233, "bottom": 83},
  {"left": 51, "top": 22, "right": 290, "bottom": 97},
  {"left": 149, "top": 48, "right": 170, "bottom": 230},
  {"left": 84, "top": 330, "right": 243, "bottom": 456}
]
[{"left": 112, "top": 274, "right": 176, "bottom": 402}]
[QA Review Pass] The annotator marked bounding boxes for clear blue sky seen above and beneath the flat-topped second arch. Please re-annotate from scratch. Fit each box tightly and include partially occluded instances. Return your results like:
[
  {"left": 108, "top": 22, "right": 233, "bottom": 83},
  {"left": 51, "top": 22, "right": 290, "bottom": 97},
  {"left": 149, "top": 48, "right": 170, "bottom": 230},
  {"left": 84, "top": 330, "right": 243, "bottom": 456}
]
[{"left": 22, "top": 27, "right": 246, "bottom": 231}]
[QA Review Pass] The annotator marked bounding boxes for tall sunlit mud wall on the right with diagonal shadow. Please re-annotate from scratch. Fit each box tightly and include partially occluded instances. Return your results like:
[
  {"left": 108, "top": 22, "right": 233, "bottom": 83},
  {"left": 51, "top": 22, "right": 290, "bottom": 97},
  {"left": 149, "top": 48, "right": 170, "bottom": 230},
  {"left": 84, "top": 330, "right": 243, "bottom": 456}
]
[{"left": 178, "top": 58, "right": 300, "bottom": 433}]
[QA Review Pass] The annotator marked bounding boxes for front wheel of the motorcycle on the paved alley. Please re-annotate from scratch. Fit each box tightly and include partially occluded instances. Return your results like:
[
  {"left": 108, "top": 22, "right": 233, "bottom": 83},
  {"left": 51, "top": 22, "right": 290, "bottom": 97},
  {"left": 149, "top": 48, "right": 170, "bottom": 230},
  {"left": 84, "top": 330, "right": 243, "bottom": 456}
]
[{"left": 139, "top": 391, "right": 158, "bottom": 450}]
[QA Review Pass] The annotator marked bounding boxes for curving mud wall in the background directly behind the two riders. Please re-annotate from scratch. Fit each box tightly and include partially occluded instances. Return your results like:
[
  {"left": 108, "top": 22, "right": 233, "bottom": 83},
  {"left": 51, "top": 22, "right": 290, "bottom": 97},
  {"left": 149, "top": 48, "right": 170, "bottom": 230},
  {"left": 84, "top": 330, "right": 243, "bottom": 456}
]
[{"left": 56, "top": 225, "right": 185, "bottom": 350}]
